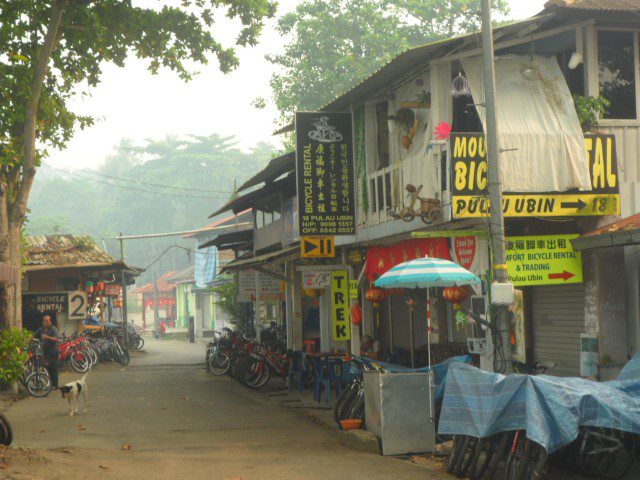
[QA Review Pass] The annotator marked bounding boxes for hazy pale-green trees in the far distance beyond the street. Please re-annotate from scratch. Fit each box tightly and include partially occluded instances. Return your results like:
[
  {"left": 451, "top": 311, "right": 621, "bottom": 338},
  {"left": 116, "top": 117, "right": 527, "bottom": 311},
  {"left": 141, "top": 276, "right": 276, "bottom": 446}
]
[{"left": 27, "top": 134, "right": 274, "bottom": 281}]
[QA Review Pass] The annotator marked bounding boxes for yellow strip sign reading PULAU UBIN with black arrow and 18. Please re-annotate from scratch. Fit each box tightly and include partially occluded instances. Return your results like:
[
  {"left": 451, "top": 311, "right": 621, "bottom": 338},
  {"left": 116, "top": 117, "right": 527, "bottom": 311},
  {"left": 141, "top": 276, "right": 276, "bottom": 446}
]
[{"left": 453, "top": 193, "right": 620, "bottom": 218}]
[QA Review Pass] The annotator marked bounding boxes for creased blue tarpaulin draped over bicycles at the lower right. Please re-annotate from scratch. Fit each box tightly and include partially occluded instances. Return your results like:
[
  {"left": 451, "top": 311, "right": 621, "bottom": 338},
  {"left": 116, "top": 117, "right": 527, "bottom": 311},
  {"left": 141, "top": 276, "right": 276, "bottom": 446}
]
[{"left": 438, "top": 354, "right": 640, "bottom": 453}]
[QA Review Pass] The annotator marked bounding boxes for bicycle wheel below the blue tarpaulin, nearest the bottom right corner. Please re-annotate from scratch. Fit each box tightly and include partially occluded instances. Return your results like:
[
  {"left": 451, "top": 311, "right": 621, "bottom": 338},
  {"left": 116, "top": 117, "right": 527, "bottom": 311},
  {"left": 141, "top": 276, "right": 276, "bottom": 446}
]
[{"left": 593, "top": 429, "right": 638, "bottom": 479}]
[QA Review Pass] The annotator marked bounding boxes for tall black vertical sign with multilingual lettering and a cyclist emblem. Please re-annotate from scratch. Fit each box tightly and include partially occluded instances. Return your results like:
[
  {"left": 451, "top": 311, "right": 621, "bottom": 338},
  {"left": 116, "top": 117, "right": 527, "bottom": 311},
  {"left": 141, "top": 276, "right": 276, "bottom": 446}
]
[{"left": 296, "top": 112, "right": 356, "bottom": 236}]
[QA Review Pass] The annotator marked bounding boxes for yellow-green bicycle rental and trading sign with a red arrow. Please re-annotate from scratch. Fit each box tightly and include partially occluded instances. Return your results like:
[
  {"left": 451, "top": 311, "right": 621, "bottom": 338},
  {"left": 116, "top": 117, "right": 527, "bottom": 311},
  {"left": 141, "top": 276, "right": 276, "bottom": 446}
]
[{"left": 506, "top": 235, "right": 582, "bottom": 286}]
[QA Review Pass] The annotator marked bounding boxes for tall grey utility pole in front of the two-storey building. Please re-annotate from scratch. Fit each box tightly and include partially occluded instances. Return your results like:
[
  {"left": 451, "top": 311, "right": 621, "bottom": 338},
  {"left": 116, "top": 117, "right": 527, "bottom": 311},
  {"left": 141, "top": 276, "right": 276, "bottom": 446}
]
[{"left": 482, "top": 0, "right": 511, "bottom": 371}]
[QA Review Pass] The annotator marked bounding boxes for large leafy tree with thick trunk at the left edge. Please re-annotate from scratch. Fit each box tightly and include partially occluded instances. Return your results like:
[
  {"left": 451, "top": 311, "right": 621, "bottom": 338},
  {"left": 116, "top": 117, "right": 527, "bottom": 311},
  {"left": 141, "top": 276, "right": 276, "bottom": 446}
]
[{"left": 0, "top": 0, "right": 275, "bottom": 328}]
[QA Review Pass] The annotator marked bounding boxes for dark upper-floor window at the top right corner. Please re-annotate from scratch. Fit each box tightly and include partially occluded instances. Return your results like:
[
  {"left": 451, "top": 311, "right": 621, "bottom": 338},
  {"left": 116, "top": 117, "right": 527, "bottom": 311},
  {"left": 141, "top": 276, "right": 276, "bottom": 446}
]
[{"left": 598, "top": 31, "right": 636, "bottom": 119}]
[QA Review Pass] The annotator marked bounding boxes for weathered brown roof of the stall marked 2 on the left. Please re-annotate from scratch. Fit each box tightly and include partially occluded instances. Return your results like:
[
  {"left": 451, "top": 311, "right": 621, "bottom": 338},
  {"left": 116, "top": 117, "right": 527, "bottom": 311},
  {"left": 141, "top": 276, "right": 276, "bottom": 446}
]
[{"left": 25, "top": 235, "right": 116, "bottom": 266}]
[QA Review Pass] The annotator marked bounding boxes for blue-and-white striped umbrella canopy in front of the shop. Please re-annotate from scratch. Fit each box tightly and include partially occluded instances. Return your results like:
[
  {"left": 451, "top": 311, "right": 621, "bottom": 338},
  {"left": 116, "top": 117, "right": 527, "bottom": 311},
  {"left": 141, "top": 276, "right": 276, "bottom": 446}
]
[{"left": 373, "top": 257, "right": 480, "bottom": 288}]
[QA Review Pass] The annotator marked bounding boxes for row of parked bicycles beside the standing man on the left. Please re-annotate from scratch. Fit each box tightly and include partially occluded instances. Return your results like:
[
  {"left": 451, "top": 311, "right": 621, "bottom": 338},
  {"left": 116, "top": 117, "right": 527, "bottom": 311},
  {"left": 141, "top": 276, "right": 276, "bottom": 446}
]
[{"left": 22, "top": 329, "right": 144, "bottom": 397}]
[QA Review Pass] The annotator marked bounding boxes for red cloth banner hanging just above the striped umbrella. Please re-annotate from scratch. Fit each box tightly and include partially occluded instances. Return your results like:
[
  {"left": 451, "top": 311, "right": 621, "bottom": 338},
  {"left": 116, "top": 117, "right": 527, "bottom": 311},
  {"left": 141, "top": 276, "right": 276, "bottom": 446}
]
[{"left": 364, "top": 238, "right": 451, "bottom": 282}]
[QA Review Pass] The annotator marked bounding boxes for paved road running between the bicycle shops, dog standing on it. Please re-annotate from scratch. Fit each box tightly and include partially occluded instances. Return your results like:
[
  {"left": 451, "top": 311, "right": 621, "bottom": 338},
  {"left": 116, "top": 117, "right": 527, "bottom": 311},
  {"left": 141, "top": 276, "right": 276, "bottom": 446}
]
[{"left": 0, "top": 340, "right": 448, "bottom": 480}]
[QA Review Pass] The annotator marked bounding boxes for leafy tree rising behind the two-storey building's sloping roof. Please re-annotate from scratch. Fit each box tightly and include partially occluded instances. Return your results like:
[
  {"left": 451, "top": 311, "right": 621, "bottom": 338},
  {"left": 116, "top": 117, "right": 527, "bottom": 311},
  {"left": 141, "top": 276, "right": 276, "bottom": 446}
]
[{"left": 262, "top": 0, "right": 508, "bottom": 123}]
